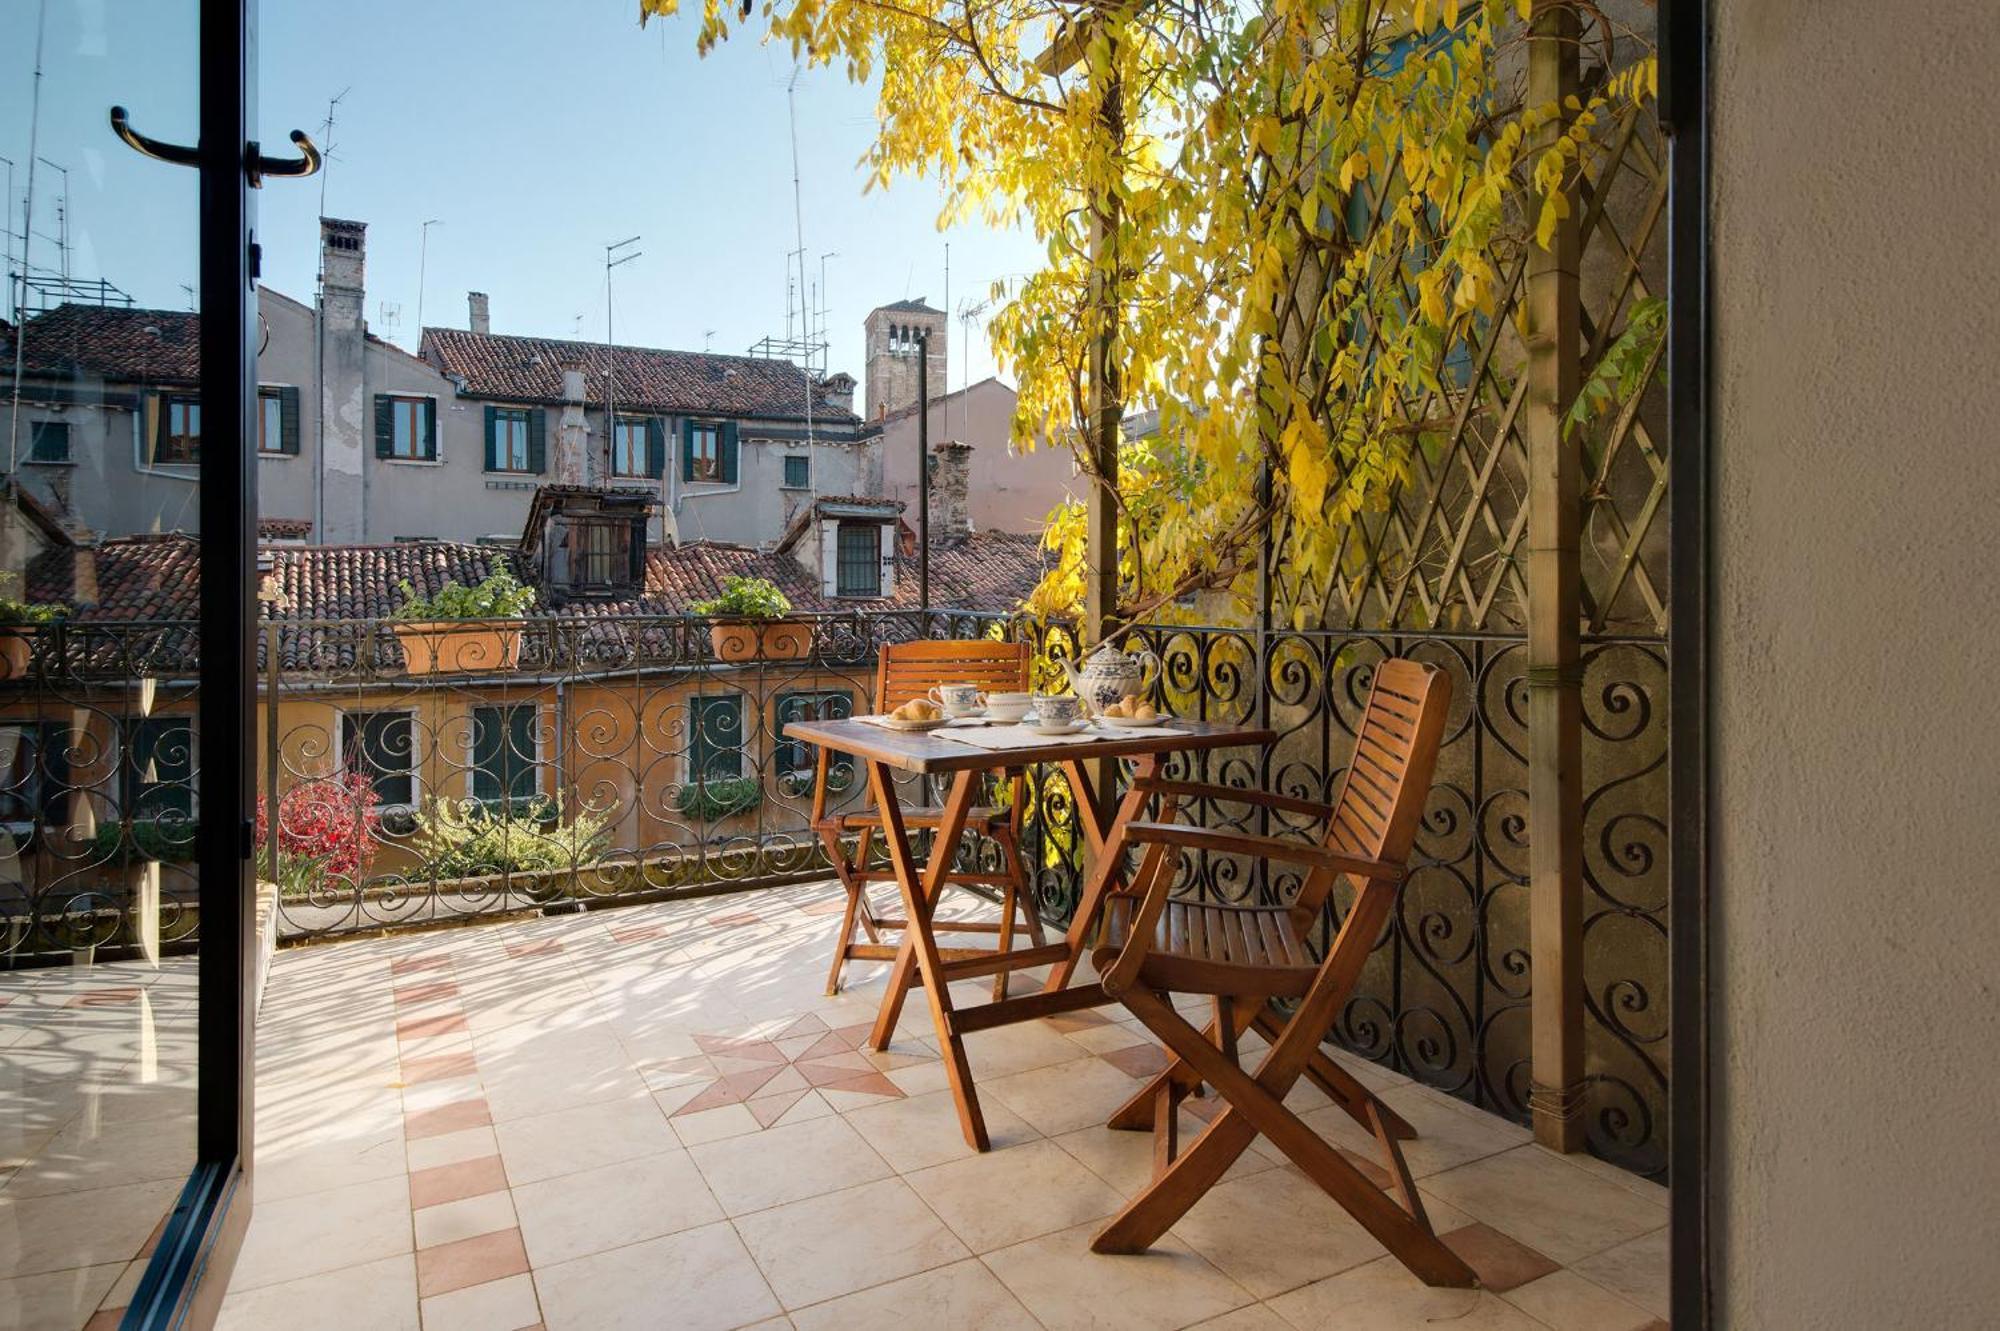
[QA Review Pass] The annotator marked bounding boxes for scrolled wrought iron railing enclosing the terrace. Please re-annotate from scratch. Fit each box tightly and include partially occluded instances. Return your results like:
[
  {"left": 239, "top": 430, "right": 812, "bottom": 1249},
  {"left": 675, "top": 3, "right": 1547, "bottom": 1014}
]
[{"left": 0, "top": 612, "right": 1666, "bottom": 1171}]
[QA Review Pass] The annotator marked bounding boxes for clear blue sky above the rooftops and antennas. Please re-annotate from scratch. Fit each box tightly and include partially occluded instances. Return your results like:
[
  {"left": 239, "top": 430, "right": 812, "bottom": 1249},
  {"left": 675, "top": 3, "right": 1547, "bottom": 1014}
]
[{"left": 0, "top": 0, "right": 1040, "bottom": 386}]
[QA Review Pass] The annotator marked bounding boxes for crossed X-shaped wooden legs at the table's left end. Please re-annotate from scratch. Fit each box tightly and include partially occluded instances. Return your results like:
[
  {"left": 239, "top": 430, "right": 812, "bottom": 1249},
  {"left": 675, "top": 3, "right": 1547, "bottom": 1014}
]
[{"left": 868, "top": 763, "right": 988, "bottom": 1151}]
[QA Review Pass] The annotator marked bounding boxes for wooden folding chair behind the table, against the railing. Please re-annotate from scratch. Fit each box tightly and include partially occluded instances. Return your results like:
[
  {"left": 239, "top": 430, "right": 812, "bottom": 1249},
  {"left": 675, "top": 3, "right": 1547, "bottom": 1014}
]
[{"left": 812, "top": 638, "right": 1042, "bottom": 999}]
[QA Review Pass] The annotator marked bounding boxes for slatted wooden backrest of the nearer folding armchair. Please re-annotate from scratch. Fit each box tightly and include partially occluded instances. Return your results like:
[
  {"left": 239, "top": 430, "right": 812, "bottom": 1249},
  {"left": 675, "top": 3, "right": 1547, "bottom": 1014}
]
[{"left": 1298, "top": 658, "right": 1452, "bottom": 911}]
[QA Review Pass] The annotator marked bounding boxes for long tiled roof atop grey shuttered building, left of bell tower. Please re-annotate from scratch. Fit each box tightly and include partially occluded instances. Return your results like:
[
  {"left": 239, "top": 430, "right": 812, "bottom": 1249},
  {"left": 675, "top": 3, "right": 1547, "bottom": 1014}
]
[{"left": 424, "top": 328, "right": 856, "bottom": 424}]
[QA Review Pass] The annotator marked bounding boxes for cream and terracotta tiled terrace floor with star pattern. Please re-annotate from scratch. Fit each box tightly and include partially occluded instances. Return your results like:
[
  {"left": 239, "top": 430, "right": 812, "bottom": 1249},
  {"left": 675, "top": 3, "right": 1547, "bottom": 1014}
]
[{"left": 222, "top": 883, "right": 1666, "bottom": 1331}]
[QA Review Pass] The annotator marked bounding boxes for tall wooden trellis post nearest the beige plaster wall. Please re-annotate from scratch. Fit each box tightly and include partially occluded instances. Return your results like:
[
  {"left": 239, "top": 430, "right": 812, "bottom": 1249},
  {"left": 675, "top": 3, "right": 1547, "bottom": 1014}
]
[{"left": 1524, "top": 0, "right": 1584, "bottom": 1151}]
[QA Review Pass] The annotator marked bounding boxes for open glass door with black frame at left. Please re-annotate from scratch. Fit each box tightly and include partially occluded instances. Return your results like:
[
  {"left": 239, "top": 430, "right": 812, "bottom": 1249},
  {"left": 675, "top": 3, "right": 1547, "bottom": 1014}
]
[{"left": 0, "top": 0, "right": 272, "bottom": 1327}]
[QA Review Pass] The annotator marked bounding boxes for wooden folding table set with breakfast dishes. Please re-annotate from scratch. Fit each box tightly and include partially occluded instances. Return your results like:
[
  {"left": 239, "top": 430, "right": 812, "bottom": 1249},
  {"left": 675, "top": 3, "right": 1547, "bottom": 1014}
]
[{"left": 784, "top": 717, "right": 1274, "bottom": 1151}]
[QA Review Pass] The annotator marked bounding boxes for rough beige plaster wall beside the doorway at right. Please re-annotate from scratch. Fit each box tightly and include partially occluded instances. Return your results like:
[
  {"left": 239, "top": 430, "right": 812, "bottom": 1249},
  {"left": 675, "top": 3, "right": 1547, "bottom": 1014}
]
[{"left": 1712, "top": 0, "right": 2000, "bottom": 1327}]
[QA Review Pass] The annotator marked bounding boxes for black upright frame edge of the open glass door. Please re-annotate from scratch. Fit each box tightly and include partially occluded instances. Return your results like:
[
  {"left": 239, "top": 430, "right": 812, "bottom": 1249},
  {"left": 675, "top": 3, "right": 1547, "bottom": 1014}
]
[{"left": 120, "top": 0, "right": 256, "bottom": 1331}]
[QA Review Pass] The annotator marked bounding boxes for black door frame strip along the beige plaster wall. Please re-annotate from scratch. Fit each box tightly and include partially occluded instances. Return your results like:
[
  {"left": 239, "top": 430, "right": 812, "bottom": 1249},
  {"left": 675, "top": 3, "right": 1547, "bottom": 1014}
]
[{"left": 1658, "top": 0, "right": 1714, "bottom": 1331}]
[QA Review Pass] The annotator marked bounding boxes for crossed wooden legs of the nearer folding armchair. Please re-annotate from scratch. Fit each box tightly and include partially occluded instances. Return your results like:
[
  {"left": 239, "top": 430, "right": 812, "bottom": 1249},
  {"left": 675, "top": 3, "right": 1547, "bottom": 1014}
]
[{"left": 1090, "top": 987, "right": 1478, "bottom": 1289}]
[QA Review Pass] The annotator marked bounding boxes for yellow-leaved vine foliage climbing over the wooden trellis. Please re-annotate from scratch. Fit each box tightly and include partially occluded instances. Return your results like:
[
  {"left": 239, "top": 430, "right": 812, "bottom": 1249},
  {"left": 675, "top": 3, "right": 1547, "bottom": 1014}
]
[{"left": 640, "top": 0, "right": 1658, "bottom": 624}]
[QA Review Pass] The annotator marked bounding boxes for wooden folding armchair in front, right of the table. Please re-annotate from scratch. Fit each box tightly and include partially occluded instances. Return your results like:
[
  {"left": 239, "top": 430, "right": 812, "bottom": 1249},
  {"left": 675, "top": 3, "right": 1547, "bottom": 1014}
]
[{"left": 1090, "top": 660, "right": 1474, "bottom": 1287}]
